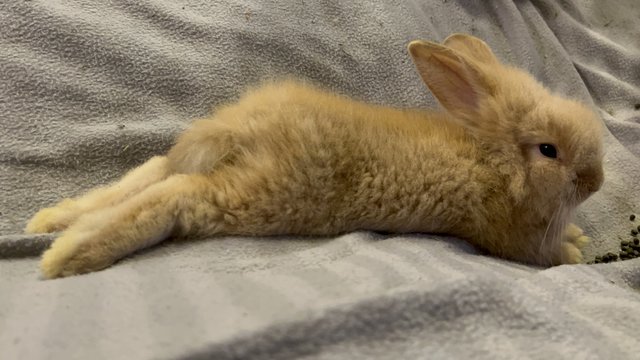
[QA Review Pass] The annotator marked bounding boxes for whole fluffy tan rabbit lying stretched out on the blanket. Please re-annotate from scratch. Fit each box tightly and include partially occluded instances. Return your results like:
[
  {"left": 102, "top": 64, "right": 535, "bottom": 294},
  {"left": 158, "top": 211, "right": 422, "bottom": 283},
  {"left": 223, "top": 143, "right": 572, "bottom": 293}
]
[{"left": 26, "top": 34, "right": 603, "bottom": 278}]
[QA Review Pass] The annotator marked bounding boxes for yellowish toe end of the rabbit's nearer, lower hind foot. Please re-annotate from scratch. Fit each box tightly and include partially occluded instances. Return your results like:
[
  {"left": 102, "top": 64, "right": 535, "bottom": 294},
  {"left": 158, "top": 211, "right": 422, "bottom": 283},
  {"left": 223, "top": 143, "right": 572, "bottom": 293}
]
[{"left": 40, "top": 231, "right": 115, "bottom": 279}]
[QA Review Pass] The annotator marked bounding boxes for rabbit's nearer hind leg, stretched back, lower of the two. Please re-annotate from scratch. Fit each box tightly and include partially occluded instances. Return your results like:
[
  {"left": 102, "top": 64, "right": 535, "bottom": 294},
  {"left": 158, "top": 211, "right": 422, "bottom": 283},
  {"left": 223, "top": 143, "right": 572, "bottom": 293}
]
[{"left": 40, "top": 174, "right": 228, "bottom": 278}]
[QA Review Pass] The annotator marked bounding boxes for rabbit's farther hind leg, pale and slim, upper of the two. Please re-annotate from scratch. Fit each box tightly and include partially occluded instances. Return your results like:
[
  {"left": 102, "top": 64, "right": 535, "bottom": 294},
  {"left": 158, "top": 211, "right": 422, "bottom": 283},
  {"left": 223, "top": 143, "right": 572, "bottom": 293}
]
[{"left": 25, "top": 156, "right": 170, "bottom": 234}]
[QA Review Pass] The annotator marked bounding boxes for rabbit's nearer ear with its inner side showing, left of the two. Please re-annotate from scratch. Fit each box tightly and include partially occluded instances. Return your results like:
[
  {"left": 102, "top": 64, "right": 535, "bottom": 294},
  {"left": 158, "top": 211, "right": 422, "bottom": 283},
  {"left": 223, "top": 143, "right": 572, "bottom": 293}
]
[{"left": 409, "top": 41, "right": 492, "bottom": 120}]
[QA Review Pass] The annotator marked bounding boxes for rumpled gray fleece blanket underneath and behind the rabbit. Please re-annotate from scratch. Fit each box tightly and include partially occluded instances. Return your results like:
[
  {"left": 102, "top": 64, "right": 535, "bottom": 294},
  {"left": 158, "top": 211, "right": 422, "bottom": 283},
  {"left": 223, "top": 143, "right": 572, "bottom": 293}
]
[{"left": 0, "top": 0, "right": 640, "bottom": 359}]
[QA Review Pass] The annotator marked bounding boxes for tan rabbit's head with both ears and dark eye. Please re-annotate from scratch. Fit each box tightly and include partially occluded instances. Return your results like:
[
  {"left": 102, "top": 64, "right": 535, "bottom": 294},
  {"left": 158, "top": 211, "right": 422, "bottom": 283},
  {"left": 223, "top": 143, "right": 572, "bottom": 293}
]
[{"left": 409, "top": 34, "right": 604, "bottom": 258}]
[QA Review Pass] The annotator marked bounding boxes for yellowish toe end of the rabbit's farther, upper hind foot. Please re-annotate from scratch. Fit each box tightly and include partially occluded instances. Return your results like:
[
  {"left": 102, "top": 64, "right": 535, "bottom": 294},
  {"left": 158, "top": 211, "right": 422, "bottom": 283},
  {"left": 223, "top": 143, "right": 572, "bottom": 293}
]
[{"left": 25, "top": 199, "right": 78, "bottom": 234}]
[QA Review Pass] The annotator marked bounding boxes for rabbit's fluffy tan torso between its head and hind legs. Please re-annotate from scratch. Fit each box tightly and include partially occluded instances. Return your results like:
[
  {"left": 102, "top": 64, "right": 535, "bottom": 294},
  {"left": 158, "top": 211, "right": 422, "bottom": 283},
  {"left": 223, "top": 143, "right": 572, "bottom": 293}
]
[{"left": 168, "top": 82, "right": 490, "bottom": 235}]
